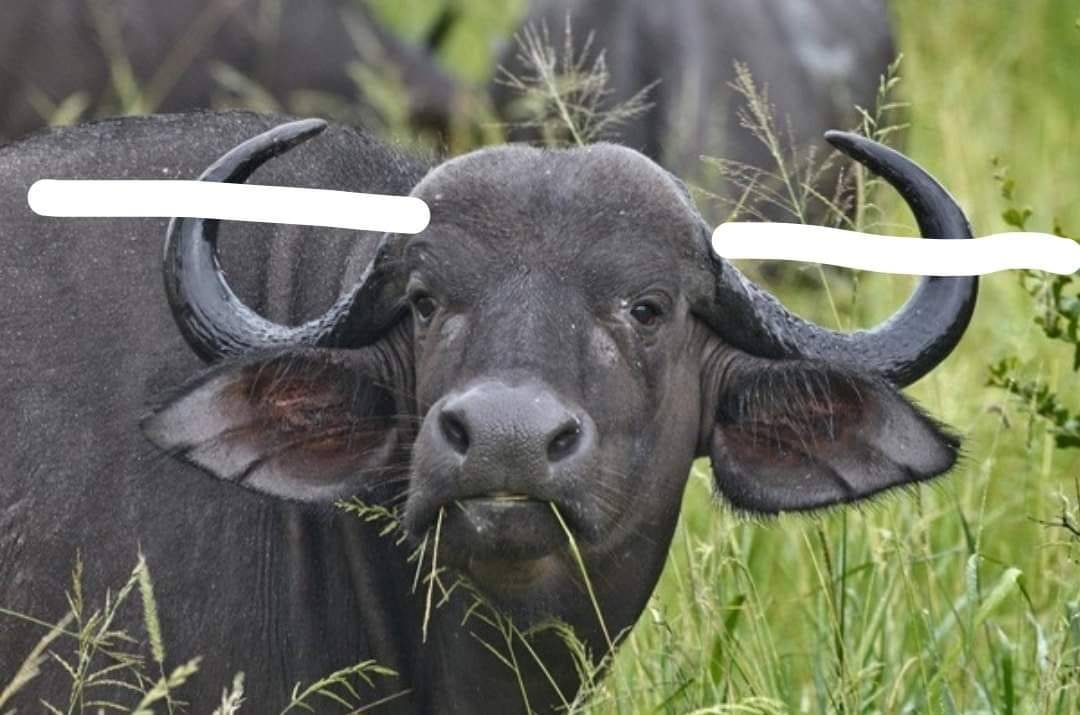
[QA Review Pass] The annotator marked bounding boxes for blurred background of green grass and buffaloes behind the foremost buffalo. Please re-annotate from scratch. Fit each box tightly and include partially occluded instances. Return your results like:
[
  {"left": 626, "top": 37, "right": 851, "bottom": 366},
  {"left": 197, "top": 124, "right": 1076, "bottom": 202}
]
[{"left": 0, "top": 0, "right": 1080, "bottom": 714}]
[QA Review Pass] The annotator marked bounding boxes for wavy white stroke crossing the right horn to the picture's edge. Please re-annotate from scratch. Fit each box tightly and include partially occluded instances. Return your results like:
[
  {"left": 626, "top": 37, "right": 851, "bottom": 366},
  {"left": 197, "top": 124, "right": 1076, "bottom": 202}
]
[{"left": 713, "top": 221, "right": 1080, "bottom": 275}]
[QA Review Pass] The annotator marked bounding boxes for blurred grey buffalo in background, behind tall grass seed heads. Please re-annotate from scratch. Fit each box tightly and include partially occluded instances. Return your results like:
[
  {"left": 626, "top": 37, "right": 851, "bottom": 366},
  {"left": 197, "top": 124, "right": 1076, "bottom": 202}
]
[{"left": 491, "top": 0, "right": 896, "bottom": 220}]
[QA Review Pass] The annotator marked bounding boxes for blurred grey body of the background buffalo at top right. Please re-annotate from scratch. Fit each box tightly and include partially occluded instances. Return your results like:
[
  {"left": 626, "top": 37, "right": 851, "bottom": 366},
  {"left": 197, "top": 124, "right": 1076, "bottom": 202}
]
[{"left": 492, "top": 0, "right": 895, "bottom": 210}]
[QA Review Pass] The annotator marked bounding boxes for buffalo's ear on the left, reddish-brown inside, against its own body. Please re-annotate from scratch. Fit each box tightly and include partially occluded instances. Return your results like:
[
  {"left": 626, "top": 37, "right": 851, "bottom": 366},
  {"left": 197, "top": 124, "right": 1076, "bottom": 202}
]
[{"left": 143, "top": 349, "right": 411, "bottom": 502}]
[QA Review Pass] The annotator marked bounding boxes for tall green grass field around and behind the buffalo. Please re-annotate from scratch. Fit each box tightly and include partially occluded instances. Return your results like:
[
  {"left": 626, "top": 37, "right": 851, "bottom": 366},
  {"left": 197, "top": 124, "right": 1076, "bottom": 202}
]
[{"left": 0, "top": 0, "right": 1080, "bottom": 715}]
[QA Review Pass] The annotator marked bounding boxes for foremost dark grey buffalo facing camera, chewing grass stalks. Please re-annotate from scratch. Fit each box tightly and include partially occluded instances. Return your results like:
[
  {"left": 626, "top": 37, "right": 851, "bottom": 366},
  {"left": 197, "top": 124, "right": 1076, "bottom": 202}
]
[{"left": 0, "top": 113, "right": 976, "bottom": 713}]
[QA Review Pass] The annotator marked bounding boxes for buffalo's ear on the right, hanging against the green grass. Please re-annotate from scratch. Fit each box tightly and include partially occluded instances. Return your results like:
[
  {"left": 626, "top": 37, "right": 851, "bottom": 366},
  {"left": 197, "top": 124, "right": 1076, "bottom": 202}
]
[{"left": 708, "top": 360, "right": 959, "bottom": 514}]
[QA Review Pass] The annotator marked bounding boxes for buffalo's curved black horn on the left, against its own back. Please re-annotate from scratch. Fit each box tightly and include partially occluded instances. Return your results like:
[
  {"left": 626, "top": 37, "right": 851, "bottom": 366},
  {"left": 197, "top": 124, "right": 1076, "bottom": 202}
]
[{"left": 163, "top": 119, "right": 403, "bottom": 362}]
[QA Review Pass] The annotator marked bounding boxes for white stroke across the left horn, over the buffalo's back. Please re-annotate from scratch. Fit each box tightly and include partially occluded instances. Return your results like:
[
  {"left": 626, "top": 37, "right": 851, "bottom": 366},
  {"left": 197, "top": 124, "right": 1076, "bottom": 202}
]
[{"left": 27, "top": 179, "right": 431, "bottom": 233}]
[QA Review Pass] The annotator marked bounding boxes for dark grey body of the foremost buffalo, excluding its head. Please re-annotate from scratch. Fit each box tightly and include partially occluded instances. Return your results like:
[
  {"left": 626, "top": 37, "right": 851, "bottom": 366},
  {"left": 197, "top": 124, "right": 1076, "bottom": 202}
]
[{"left": 0, "top": 114, "right": 434, "bottom": 713}]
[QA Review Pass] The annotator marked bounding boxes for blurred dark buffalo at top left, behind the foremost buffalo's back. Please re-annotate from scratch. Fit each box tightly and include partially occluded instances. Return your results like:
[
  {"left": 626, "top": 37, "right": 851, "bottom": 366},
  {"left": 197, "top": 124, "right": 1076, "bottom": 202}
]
[{"left": 0, "top": 0, "right": 455, "bottom": 140}]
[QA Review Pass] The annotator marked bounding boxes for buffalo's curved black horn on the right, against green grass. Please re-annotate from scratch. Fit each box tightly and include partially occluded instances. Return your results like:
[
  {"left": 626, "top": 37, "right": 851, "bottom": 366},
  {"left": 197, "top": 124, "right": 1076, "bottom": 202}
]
[{"left": 694, "top": 132, "right": 978, "bottom": 386}]
